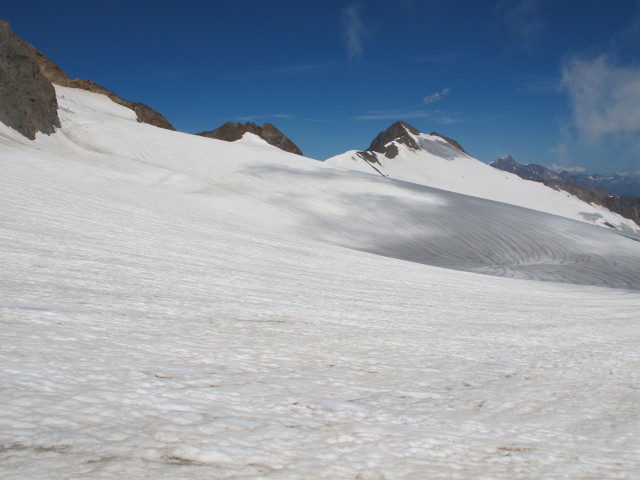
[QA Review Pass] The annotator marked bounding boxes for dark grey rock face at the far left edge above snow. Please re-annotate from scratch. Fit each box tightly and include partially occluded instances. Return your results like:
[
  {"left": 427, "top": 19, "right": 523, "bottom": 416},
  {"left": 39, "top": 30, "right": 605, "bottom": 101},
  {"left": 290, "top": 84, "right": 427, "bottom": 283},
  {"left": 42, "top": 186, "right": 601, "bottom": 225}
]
[{"left": 0, "top": 20, "right": 60, "bottom": 139}]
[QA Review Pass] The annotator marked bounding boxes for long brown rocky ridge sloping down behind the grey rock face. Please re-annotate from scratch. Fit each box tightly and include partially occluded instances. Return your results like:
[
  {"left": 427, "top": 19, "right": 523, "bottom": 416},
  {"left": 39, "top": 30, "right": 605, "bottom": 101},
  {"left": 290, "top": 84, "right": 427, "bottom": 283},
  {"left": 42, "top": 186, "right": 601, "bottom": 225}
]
[{"left": 0, "top": 20, "right": 175, "bottom": 133}]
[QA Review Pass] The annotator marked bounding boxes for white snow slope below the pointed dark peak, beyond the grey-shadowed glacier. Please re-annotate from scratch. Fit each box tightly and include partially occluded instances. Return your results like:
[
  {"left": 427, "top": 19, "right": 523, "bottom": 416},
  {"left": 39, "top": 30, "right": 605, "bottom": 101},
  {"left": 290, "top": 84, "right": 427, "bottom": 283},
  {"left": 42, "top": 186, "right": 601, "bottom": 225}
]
[{"left": 325, "top": 129, "right": 640, "bottom": 232}]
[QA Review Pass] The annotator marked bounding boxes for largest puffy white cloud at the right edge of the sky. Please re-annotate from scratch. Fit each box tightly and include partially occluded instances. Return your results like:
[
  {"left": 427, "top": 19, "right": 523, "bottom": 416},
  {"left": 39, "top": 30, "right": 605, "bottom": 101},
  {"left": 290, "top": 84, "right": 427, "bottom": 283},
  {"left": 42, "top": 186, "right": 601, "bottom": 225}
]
[{"left": 562, "top": 55, "right": 640, "bottom": 139}]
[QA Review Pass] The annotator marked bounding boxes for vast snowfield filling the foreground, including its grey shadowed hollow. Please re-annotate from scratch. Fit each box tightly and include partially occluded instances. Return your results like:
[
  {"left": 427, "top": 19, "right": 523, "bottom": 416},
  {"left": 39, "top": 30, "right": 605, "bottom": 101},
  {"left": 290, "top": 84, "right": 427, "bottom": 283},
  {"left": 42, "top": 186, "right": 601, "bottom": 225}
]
[{"left": 0, "top": 88, "right": 640, "bottom": 479}]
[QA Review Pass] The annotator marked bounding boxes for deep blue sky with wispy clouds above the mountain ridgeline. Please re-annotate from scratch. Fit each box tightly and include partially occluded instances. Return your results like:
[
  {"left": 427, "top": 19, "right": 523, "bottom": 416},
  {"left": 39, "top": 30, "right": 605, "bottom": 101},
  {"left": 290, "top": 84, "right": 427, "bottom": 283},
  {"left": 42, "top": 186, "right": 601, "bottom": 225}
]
[{"left": 0, "top": 0, "right": 640, "bottom": 173}]
